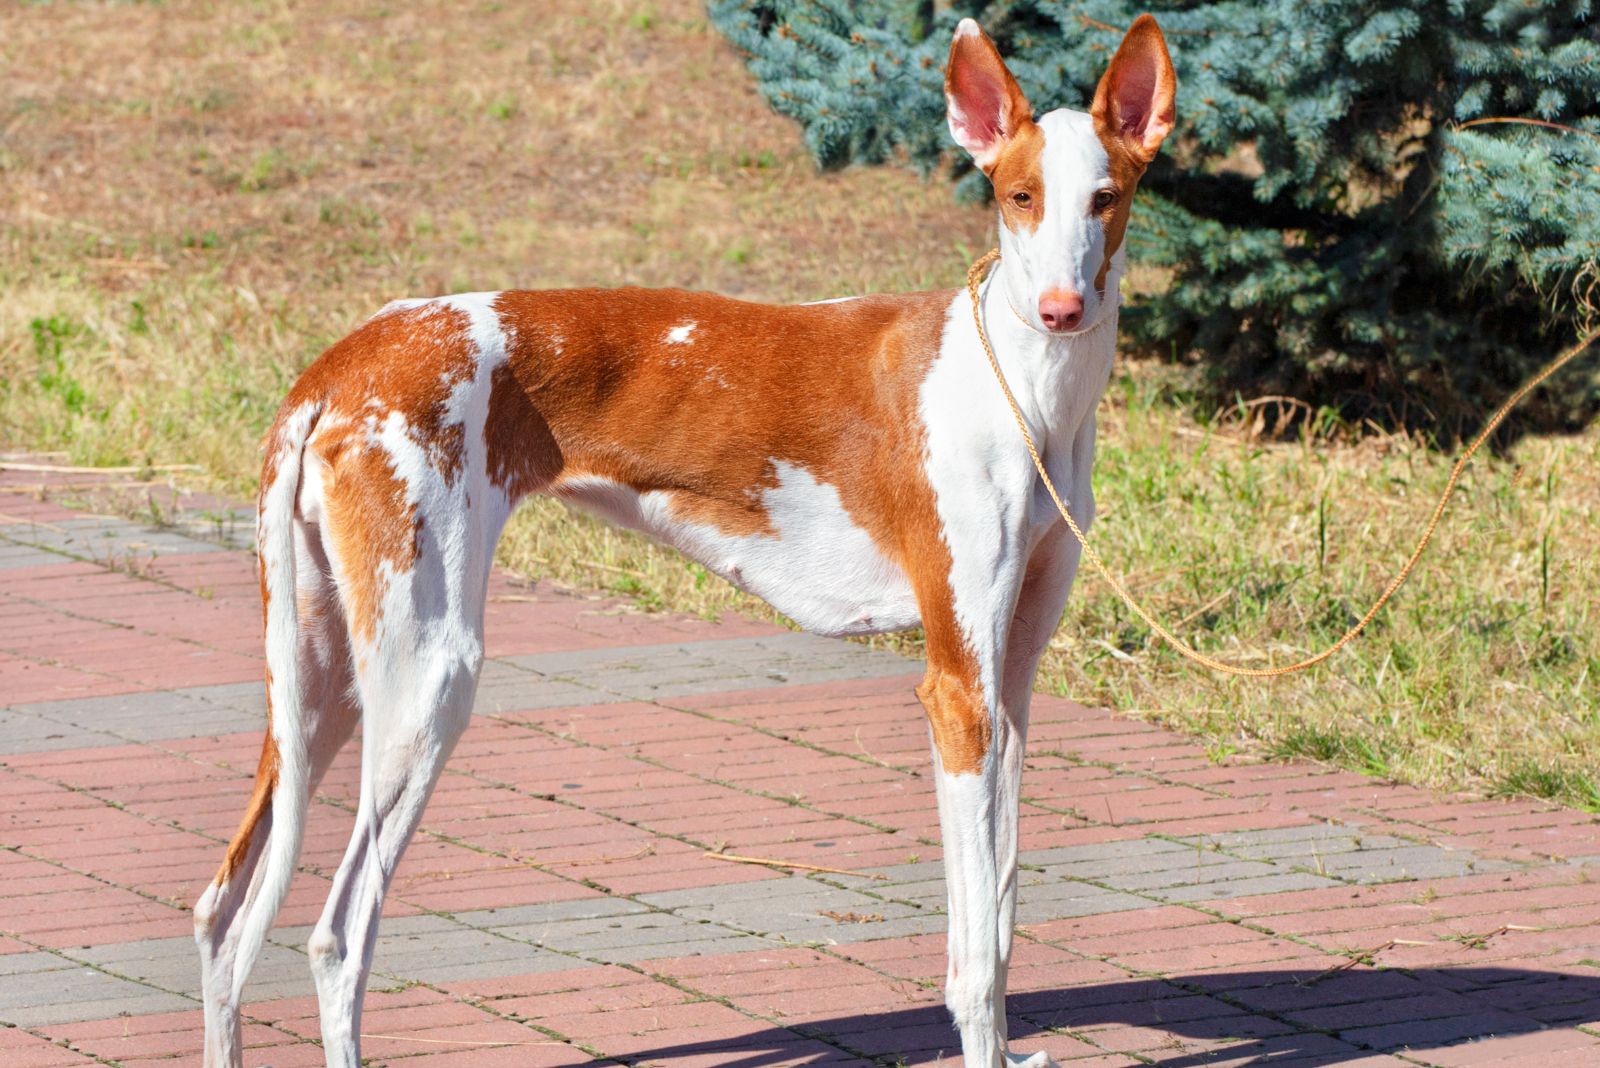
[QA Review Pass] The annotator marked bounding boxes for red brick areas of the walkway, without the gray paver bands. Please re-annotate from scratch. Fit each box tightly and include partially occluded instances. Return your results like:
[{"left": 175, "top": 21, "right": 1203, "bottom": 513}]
[{"left": 0, "top": 472, "right": 1600, "bottom": 1068}]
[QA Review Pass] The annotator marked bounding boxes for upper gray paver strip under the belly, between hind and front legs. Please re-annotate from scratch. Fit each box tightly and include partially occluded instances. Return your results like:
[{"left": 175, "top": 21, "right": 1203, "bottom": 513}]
[{"left": 509, "top": 633, "right": 920, "bottom": 700}]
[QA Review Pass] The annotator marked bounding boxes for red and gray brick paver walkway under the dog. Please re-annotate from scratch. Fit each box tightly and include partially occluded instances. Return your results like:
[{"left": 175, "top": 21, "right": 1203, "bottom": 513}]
[{"left": 0, "top": 454, "right": 1600, "bottom": 1068}]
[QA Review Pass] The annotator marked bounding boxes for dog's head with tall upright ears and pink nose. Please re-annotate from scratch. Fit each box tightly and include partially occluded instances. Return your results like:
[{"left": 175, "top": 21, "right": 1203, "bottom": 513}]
[{"left": 944, "top": 14, "right": 1178, "bottom": 334}]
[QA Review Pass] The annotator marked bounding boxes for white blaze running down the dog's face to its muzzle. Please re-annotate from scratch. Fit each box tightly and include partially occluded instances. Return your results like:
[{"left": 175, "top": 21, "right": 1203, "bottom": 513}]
[{"left": 1000, "top": 109, "right": 1115, "bottom": 329}]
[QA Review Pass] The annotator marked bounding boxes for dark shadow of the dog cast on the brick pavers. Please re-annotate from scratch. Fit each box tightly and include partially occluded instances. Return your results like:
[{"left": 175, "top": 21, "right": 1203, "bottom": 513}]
[{"left": 595, "top": 966, "right": 1600, "bottom": 1068}]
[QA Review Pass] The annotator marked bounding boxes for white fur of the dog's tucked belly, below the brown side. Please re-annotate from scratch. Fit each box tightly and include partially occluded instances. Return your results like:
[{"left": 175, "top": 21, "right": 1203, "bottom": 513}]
[{"left": 549, "top": 462, "right": 922, "bottom": 635}]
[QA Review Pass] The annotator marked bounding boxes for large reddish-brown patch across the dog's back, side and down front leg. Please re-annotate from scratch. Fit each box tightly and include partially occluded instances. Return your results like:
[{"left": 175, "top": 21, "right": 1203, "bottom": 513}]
[{"left": 493, "top": 288, "right": 989, "bottom": 774}]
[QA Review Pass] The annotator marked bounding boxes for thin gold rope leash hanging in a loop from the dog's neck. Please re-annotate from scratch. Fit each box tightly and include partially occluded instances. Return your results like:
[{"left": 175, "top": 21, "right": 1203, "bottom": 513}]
[{"left": 966, "top": 248, "right": 1600, "bottom": 678}]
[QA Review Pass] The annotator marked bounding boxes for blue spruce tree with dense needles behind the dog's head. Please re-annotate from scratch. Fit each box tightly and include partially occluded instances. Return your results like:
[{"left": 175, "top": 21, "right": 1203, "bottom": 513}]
[{"left": 710, "top": 0, "right": 1600, "bottom": 436}]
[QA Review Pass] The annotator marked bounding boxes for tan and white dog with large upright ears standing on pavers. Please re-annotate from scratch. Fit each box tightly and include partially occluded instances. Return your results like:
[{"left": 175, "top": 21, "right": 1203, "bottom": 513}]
[{"left": 195, "top": 16, "right": 1176, "bottom": 1068}]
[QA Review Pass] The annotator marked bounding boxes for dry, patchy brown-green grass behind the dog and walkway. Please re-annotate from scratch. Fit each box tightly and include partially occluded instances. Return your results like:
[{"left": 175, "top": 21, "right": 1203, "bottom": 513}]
[{"left": 0, "top": 0, "right": 1600, "bottom": 804}]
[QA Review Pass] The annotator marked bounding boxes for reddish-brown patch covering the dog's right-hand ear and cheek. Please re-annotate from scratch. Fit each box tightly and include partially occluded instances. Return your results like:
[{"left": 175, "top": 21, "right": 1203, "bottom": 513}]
[{"left": 1090, "top": 14, "right": 1178, "bottom": 293}]
